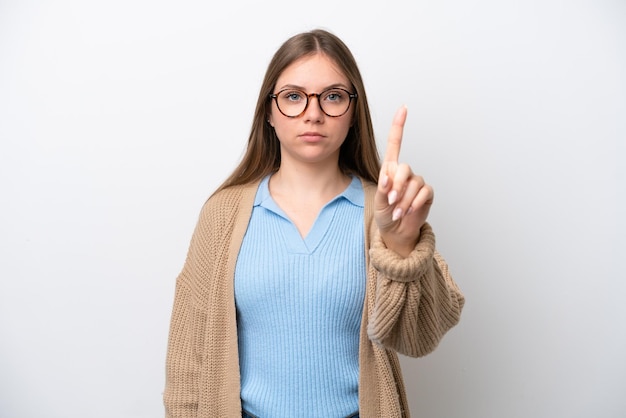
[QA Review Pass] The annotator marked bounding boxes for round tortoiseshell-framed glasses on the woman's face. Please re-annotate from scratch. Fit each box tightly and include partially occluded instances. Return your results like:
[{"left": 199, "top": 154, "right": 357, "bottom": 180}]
[{"left": 270, "top": 88, "right": 357, "bottom": 118}]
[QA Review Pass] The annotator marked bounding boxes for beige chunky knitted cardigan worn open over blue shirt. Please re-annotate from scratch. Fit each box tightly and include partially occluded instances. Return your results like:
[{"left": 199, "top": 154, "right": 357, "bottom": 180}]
[{"left": 163, "top": 182, "right": 464, "bottom": 418}]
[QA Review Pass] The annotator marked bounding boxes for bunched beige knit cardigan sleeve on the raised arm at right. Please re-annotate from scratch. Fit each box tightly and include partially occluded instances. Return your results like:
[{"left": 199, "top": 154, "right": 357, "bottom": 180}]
[{"left": 367, "top": 223, "right": 465, "bottom": 357}]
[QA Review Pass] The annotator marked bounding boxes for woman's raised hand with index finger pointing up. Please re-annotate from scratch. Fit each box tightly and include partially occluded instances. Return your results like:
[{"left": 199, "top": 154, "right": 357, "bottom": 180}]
[{"left": 374, "top": 106, "right": 434, "bottom": 257}]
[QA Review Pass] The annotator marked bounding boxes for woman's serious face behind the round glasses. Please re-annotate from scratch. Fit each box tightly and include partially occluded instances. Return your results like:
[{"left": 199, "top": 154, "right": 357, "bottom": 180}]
[{"left": 269, "top": 54, "right": 354, "bottom": 165}]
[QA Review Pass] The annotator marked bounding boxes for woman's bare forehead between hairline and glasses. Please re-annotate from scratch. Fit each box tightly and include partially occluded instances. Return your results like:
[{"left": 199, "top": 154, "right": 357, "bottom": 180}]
[{"left": 276, "top": 54, "right": 350, "bottom": 91}]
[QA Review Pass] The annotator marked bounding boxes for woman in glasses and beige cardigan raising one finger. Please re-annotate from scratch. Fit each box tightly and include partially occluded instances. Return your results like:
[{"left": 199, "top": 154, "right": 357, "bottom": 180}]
[{"left": 164, "top": 30, "right": 464, "bottom": 418}]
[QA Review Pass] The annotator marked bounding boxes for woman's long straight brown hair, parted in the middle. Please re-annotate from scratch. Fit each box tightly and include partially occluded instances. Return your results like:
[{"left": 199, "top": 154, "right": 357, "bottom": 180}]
[{"left": 216, "top": 29, "right": 380, "bottom": 192}]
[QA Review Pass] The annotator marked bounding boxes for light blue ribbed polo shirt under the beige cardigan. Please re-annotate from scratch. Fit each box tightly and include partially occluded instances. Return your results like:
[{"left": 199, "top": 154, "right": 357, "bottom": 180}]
[{"left": 235, "top": 176, "right": 366, "bottom": 418}]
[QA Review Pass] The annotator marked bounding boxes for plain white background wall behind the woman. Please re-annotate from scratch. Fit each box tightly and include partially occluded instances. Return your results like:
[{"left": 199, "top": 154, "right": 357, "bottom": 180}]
[{"left": 0, "top": 0, "right": 626, "bottom": 418}]
